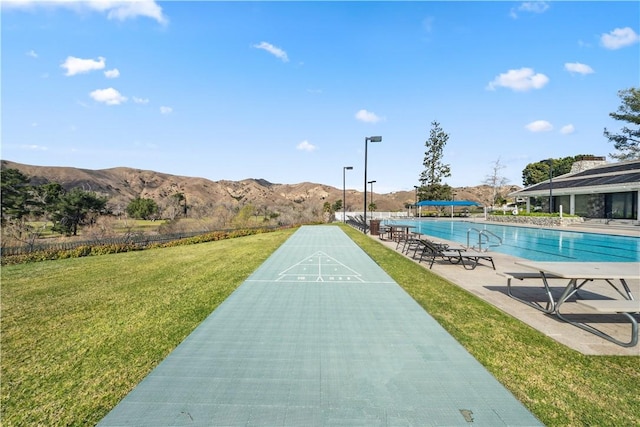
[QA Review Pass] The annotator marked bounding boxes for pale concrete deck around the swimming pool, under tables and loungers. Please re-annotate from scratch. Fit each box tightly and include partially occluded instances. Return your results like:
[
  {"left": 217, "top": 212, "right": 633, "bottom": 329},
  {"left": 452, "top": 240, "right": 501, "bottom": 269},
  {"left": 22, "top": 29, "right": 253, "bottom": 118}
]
[{"left": 372, "top": 219, "right": 640, "bottom": 356}]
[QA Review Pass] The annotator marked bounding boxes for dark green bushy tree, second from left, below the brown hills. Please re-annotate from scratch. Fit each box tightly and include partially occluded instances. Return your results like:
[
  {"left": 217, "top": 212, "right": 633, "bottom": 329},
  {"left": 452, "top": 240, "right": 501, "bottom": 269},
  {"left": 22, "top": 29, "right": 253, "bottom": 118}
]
[{"left": 51, "top": 188, "right": 107, "bottom": 236}]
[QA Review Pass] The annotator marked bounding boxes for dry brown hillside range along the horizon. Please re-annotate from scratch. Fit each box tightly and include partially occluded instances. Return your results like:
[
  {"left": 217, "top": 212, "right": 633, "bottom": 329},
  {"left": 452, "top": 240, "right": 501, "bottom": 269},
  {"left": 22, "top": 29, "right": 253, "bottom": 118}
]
[{"left": 2, "top": 160, "right": 519, "bottom": 216}]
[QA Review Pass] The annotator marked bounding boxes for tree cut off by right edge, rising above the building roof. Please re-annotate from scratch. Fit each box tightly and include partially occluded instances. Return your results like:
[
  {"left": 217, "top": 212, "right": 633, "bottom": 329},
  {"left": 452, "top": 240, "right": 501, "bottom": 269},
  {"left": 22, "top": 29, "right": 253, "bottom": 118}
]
[{"left": 604, "top": 87, "right": 640, "bottom": 160}]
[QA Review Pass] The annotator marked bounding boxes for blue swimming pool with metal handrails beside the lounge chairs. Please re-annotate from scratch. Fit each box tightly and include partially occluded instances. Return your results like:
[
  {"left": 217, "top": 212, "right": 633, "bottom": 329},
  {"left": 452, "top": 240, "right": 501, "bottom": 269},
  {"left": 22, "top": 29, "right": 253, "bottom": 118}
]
[{"left": 390, "top": 220, "right": 640, "bottom": 262}]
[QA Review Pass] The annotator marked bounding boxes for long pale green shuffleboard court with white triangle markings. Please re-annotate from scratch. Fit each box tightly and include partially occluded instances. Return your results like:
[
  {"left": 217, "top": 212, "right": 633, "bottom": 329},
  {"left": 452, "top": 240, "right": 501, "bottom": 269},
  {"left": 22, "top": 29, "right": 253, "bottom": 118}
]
[{"left": 100, "top": 226, "right": 541, "bottom": 426}]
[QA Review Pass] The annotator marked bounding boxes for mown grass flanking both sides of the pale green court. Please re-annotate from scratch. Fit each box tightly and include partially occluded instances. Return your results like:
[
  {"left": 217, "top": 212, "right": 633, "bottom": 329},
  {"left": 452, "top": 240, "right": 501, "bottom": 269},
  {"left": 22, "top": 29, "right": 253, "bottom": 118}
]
[{"left": 0, "top": 227, "right": 640, "bottom": 426}]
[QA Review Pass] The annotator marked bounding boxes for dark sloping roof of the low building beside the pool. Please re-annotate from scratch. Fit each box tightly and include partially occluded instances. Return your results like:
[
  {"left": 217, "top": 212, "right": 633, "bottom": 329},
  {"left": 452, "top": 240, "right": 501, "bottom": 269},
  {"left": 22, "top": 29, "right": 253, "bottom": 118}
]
[{"left": 510, "top": 160, "right": 640, "bottom": 197}]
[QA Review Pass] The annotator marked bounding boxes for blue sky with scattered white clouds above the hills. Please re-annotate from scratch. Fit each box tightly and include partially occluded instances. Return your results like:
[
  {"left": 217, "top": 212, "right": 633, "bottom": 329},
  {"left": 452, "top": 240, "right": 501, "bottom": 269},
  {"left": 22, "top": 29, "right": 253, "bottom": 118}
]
[{"left": 1, "top": 0, "right": 640, "bottom": 193}]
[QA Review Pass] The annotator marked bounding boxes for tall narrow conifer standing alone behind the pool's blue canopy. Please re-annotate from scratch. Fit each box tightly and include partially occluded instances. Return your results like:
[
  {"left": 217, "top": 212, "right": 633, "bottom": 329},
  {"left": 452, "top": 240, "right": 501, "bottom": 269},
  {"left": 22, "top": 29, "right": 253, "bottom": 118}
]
[{"left": 418, "top": 121, "right": 453, "bottom": 200}]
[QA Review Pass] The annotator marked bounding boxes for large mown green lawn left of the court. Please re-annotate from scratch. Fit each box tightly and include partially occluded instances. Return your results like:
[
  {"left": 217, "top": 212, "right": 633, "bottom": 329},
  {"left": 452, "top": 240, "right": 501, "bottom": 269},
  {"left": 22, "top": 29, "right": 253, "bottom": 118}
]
[{"left": 1, "top": 229, "right": 294, "bottom": 426}]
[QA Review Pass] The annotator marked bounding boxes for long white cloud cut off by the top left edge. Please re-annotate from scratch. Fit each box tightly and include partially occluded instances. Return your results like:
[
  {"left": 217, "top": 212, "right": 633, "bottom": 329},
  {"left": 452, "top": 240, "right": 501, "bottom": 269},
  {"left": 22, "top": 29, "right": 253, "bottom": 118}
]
[{"left": 2, "top": 0, "right": 169, "bottom": 24}]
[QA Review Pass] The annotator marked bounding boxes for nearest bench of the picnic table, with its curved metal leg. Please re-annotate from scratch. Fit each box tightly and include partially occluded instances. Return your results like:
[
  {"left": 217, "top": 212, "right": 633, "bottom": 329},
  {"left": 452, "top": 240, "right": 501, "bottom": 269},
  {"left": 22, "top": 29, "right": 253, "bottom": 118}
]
[{"left": 558, "top": 299, "right": 640, "bottom": 347}]
